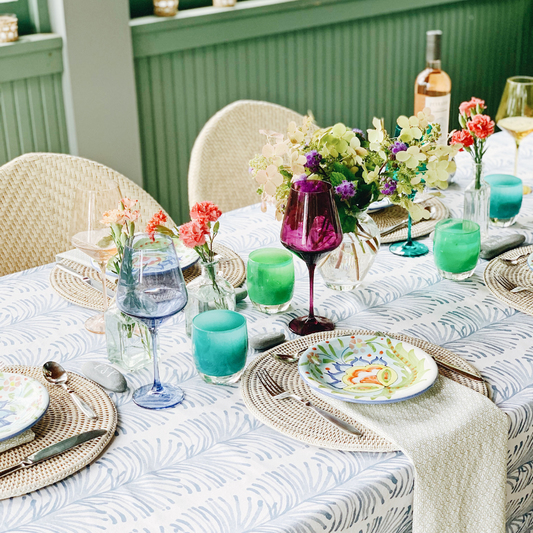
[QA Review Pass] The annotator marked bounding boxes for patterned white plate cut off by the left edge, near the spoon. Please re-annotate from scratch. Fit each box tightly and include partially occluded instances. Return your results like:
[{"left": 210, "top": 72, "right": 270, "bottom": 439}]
[{"left": 0, "top": 372, "right": 50, "bottom": 441}]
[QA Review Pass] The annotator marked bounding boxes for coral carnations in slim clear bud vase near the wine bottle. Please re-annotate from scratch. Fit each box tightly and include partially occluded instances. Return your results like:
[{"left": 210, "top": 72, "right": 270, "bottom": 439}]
[{"left": 450, "top": 97, "right": 494, "bottom": 236}]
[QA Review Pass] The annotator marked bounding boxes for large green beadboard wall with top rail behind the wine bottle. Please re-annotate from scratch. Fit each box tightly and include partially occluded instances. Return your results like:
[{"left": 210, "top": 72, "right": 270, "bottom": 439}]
[{"left": 131, "top": 0, "right": 533, "bottom": 222}]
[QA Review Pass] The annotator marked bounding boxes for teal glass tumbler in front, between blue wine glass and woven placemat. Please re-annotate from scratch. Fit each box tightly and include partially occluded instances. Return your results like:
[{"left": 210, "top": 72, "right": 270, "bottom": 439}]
[{"left": 191, "top": 309, "right": 248, "bottom": 385}]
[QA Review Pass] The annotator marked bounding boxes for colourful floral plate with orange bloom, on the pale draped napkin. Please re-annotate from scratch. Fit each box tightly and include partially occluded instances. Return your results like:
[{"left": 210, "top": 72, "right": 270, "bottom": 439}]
[{"left": 298, "top": 335, "right": 438, "bottom": 403}]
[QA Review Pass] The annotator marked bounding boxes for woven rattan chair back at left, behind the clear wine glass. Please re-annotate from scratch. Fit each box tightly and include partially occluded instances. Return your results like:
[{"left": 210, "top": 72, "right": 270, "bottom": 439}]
[{"left": 0, "top": 153, "right": 170, "bottom": 276}]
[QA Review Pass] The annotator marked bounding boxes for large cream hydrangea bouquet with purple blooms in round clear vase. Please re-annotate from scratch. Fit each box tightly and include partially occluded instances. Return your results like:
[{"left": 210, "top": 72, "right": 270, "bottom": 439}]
[{"left": 250, "top": 109, "right": 460, "bottom": 278}]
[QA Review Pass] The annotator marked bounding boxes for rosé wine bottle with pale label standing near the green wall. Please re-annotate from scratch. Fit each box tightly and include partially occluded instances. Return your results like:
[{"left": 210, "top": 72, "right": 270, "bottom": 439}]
[{"left": 415, "top": 30, "right": 452, "bottom": 144}]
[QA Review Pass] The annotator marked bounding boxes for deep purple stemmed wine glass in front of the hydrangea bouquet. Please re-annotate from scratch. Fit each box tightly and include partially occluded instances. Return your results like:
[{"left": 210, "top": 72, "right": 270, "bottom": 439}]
[{"left": 280, "top": 180, "right": 342, "bottom": 335}]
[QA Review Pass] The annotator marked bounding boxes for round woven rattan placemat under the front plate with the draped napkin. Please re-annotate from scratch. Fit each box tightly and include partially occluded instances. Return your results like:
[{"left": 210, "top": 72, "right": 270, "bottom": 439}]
[{"left": 241, "top": 330, "right": 489, "bottom": 452}]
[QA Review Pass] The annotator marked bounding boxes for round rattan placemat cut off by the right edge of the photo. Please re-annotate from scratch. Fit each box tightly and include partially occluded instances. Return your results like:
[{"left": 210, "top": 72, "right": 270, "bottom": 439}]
[{"left": 483, "top": 246, "right": 533, "bottom": 315}]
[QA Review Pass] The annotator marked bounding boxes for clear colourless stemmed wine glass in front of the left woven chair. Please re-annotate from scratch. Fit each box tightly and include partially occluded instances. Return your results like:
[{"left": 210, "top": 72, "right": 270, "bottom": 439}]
[{"left": 70, "top": 180, "right": 121, "bottom": 333}]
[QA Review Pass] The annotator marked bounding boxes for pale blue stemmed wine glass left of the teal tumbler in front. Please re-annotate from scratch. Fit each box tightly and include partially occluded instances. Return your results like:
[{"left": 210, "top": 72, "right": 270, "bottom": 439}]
[{"left": 117, "top": 233, "right": 187, "bottom": 409}]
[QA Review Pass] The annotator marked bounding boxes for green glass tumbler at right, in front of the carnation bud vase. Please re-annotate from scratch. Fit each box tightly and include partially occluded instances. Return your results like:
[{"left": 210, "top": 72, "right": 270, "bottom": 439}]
[{"left": 433, "top": 218, "right": 481, "bottom": 281}]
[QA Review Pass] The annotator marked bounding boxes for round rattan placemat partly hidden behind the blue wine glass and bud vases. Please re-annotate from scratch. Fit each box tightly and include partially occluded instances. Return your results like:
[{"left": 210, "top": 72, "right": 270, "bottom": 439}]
[{"left": 50, "top": 244, "right": 246, "bottom": 311}]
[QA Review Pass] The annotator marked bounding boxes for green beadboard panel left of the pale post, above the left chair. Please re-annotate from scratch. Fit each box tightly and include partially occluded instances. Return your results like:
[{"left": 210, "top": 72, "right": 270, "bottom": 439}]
[{"left": 0, "top": 74, "right": 68, "bottom": 165}]
